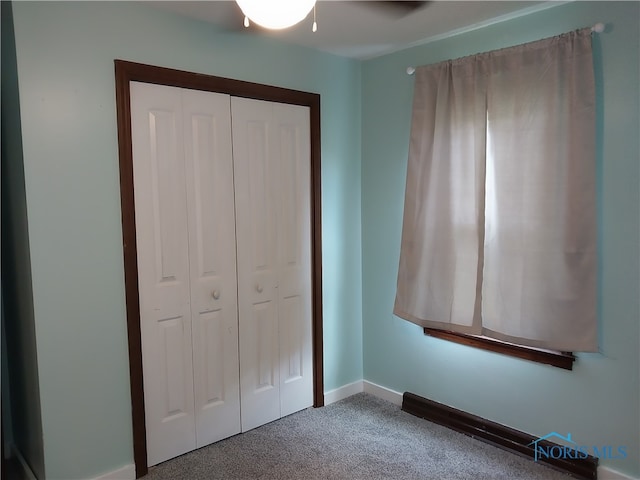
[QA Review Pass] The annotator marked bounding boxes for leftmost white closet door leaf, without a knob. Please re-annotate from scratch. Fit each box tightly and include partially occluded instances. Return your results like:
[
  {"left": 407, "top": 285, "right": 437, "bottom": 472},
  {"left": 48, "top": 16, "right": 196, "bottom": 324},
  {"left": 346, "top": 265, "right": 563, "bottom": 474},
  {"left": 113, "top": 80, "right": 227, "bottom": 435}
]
[{"left": 131, "top": 82, "right": 196, "bottom": 465}]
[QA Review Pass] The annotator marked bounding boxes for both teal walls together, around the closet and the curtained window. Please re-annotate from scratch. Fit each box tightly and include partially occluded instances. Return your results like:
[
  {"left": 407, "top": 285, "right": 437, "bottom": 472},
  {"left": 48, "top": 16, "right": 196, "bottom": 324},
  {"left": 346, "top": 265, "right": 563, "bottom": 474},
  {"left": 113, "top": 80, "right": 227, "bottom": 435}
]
[{"left": 10, "top": 2, "right": 640, "bottom": 479}]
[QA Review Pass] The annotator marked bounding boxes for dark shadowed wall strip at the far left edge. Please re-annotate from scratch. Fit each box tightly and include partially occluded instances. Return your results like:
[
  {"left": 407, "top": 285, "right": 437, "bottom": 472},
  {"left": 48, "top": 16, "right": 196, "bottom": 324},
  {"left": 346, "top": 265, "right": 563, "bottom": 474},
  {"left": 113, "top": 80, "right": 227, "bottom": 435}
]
[{"left": 0, "top": 2, "right": 44, "bottom": 478}]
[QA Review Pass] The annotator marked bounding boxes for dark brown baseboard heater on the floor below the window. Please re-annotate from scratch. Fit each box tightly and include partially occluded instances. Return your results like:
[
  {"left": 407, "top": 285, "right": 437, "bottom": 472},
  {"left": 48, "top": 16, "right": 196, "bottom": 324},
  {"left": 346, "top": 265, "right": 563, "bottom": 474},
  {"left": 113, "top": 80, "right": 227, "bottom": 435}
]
[{"left": 402, "top": 392, "right": 598, "bottom": 480}]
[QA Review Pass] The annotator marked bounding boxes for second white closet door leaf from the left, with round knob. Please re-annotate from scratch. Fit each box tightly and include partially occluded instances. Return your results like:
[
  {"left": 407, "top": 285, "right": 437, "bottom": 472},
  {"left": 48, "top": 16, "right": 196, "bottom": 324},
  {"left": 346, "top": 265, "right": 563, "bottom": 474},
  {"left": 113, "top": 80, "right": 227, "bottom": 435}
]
[{"left": 182, "top": 90, "right": 240, "bottom": 447}]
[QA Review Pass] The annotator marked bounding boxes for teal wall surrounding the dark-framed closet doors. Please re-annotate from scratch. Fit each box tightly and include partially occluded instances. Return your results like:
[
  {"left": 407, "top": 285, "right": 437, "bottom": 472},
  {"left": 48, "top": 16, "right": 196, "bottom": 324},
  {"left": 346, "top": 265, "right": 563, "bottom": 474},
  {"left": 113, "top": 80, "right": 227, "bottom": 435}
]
[{"left": 10, "top": 2, "right": 362, "bottom": 479}]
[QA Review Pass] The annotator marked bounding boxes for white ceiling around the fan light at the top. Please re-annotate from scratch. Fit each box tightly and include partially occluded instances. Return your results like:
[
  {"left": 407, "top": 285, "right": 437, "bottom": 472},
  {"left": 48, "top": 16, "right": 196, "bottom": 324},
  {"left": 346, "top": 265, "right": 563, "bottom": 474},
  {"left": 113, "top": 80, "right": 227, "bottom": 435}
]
[{"left": 152, "top": 0, "right": 552, "bottom": 59}]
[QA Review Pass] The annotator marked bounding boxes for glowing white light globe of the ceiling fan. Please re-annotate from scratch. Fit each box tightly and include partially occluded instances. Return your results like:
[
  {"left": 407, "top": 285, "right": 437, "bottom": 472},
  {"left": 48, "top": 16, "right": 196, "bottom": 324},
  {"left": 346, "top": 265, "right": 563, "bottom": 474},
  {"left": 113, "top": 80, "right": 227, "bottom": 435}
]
[{"left": 236, "top": 0, "right": 316, "bottom": 30}]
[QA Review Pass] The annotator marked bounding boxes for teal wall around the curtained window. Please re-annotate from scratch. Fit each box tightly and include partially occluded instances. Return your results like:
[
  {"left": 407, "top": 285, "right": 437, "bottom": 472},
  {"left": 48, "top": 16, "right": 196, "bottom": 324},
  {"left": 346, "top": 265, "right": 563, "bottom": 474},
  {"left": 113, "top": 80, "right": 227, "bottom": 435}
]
[{"left": 362, "top": 2, "right": 640, "bottom": 476}]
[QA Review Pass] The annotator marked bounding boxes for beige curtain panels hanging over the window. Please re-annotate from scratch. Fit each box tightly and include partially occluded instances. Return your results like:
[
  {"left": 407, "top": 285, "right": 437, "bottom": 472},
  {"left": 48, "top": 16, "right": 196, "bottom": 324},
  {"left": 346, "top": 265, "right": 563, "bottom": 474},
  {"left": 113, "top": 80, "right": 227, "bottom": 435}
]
[{"left": 394, "top": 29, "right": 597, "bottom": 351}]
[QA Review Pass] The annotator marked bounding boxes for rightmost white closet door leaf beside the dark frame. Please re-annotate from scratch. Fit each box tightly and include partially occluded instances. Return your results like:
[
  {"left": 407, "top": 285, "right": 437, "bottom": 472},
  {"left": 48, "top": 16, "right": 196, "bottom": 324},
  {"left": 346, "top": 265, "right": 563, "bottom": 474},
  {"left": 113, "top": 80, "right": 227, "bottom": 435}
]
[{"left": 274, "top": 104, "right": 313, "bottom": 417}]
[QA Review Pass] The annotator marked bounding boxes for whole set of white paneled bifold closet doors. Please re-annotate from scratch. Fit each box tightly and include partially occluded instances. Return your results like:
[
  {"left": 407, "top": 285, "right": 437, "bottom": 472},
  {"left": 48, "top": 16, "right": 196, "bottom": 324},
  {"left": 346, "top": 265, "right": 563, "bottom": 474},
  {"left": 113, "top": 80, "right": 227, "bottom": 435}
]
[{"left": 130, "top": 82, "right": 313, "bottom": 465}]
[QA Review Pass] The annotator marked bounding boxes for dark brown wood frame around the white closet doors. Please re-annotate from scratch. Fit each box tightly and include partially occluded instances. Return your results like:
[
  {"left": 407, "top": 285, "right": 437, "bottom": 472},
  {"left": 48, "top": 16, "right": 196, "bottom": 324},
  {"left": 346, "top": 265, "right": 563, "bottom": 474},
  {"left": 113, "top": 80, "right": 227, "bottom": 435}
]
[{"left": 115, "top": 60, "right": 324, "bottom": 478}]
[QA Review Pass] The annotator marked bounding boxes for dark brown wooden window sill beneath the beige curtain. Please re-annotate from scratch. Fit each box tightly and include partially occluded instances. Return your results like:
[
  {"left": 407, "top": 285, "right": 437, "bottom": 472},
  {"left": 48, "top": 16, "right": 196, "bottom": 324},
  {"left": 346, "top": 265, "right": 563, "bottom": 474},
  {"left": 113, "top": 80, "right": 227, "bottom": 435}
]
[{"left": 424, "top": 328, "right": 576, "bottom": 370}]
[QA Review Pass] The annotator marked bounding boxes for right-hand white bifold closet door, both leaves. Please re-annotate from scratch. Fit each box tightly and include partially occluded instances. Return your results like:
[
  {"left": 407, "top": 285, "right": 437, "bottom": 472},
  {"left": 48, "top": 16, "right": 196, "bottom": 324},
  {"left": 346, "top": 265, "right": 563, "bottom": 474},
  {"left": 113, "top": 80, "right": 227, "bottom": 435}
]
[{"left": 232, "top": 98, "right": 313, "bottom": 431}]
